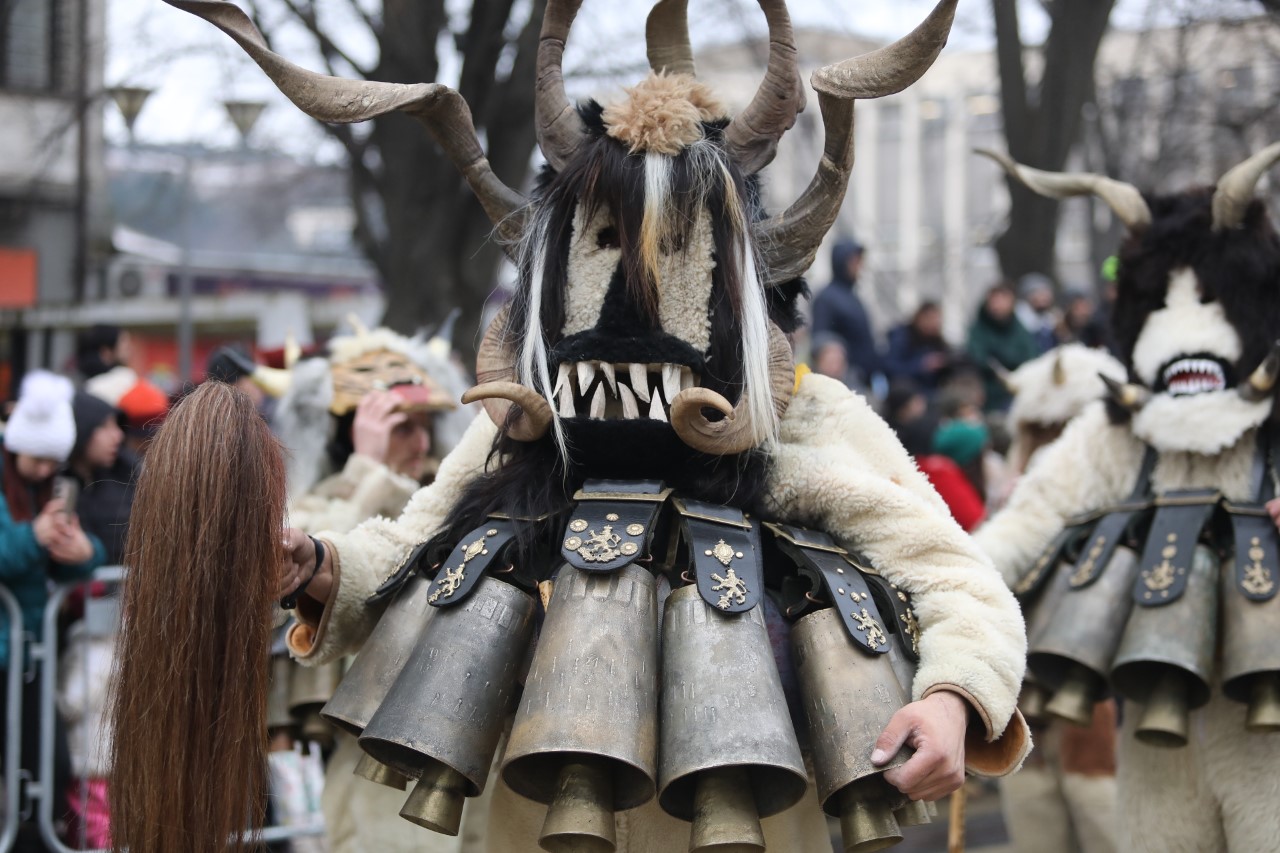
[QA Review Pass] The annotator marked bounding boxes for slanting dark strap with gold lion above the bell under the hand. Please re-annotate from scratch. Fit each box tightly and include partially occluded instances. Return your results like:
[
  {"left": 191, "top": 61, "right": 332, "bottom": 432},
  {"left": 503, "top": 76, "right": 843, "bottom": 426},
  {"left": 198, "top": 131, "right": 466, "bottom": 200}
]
[{"left": 767, "top": 523, "right": 888, "bottom": 654}]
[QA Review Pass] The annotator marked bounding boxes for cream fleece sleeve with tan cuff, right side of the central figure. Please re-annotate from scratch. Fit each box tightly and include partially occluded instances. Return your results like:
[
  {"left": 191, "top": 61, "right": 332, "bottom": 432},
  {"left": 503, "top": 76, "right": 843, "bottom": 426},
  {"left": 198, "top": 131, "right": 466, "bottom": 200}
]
[{"left": 767, "top": 375, "right": 1030, "bottom": 775}]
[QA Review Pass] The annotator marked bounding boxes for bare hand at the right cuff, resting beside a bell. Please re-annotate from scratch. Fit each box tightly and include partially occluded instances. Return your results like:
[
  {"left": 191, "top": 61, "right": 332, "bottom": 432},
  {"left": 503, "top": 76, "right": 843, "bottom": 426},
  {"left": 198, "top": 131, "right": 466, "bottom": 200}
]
[{"left": 872, "top": 690, "right": 969, "bottom": 802}]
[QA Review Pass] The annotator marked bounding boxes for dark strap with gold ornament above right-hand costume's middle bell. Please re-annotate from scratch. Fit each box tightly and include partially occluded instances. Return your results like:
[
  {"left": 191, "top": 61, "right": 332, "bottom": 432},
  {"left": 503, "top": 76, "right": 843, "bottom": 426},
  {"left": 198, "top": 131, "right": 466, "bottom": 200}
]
[{"left": 1133, "top": 489, "right": 1221, "bottom": 607}]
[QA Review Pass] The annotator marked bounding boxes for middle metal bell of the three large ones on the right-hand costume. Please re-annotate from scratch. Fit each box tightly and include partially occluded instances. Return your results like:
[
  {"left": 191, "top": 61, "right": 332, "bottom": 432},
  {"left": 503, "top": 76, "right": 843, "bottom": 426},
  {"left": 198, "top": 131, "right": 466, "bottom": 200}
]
[{"left": 1111, "top": 544, "right": 1219, "bottom": 747}]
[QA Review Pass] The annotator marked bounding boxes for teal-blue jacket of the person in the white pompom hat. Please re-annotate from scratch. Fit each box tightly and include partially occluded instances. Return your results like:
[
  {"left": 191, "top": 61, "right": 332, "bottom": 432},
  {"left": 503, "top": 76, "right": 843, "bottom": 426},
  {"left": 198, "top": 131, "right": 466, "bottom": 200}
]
[{"left": 0, "top": 471, "right": 106, "bottom": 670}]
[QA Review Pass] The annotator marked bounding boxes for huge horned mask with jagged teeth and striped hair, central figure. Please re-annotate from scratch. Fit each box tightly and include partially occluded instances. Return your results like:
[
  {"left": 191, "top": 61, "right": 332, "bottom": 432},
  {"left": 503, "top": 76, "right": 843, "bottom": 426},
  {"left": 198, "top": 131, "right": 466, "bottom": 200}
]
[{"left": 168, "top": 0, "right": 956, "bottom": 456}]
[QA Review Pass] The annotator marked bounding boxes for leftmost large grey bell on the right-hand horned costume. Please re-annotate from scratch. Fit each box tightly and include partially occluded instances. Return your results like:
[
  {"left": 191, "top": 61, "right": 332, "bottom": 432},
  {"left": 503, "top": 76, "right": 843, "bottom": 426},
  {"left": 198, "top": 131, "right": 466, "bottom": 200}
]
[{"left": 1027, "top": 546, "right": 1139, "bottom": 726}]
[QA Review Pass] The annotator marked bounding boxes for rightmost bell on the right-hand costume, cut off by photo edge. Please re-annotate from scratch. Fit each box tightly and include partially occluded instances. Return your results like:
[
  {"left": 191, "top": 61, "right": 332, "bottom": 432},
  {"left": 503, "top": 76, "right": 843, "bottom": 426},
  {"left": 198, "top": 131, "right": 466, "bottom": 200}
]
[{"left": 1221, "top": 557, "right": 1280, "bottom": 731}]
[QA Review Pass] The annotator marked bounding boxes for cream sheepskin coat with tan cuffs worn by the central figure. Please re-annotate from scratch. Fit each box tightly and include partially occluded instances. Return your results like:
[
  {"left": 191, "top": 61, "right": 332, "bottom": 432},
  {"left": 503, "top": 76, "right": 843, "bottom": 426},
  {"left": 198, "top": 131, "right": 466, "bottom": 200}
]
[{"left": 289, "top": 374, "right": 1030, "bottom": 853}]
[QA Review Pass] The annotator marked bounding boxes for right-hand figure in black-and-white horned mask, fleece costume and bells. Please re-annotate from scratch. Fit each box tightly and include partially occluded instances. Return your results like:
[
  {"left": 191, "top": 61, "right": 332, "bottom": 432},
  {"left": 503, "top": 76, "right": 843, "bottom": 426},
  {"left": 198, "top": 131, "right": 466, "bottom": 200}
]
[{"left": 978, "top": 145, "right": 1280, "bottom": 850}]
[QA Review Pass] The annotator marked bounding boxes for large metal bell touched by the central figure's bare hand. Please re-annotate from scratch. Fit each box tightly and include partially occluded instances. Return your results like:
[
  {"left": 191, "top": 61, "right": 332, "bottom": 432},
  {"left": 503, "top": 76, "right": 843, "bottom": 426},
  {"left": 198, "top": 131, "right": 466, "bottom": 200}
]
[{"left": 791, "top": 607, "right": 910, "bottom": 853}]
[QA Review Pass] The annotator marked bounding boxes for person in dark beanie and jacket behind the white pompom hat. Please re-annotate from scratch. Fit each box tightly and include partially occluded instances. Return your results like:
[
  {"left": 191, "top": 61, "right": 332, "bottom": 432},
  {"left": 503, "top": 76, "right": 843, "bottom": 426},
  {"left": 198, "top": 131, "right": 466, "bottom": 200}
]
[{"left": 67, "top": 391, "right": 138, "bottom": 565}]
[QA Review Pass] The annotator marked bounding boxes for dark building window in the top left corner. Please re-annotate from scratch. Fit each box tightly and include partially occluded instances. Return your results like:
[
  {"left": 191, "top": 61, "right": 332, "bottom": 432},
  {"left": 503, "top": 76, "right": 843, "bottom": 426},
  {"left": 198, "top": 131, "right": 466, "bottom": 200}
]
[{"left": 0, "top": 0, "right": 83, "bottom": 95}]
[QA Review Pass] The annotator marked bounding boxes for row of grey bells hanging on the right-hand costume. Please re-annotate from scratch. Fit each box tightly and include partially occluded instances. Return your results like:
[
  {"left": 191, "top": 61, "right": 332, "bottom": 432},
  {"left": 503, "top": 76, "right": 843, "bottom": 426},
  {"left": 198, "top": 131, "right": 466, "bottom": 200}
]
[{"left": 1019, "top": 544, "right": 1280, "bottom": 747}]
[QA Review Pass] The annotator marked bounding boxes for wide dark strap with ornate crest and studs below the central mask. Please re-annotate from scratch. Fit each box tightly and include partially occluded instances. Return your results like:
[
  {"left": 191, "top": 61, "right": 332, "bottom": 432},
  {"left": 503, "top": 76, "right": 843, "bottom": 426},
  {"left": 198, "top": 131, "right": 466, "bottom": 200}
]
[{"left": 561, "top": 480, "right": 671, "bottom": 571}]
